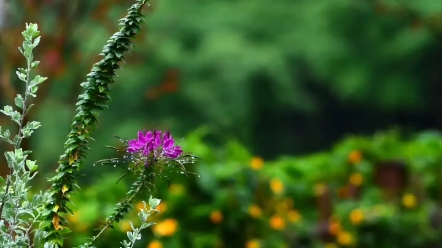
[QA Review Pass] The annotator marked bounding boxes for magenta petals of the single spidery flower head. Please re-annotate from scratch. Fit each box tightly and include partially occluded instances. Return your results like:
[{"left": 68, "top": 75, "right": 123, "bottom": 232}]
[{"left": 127, "top": 131, "right": 183, "bottom": 165}]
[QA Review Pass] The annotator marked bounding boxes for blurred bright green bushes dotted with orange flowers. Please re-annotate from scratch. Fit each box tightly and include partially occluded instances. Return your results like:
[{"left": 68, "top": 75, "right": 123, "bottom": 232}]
[{"left": 59, "top": 128, "right": 442, "bottom": 248}]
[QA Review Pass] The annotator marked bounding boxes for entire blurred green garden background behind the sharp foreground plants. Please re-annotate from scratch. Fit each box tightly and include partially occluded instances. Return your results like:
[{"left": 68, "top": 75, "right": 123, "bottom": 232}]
[{"left": 0, "top": 0, "right": 442, "bottom": 248}]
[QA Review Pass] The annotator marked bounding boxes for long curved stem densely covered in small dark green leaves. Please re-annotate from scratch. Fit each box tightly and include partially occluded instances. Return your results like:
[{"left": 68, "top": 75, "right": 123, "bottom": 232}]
[{"left": 41, "top": 0, "right": 147, "bottom": 246}]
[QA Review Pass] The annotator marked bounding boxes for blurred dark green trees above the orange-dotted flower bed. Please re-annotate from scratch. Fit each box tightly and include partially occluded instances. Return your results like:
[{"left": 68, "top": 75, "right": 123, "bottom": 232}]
[{"left": 0, "top": 0, "right": 442, "bottom": 158}]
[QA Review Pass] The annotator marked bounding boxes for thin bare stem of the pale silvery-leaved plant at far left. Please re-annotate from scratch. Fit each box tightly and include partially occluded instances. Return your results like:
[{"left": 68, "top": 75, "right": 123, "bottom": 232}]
[{"left": 0, "top": 49, "right": 33, "bottom": 220}]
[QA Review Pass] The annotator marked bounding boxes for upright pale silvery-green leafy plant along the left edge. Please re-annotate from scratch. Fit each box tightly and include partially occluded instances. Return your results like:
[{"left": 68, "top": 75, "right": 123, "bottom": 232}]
[{"left": 0, "top": 24, "right": 50, "bottom": 247}]
